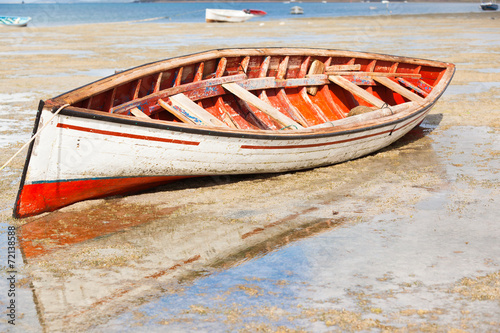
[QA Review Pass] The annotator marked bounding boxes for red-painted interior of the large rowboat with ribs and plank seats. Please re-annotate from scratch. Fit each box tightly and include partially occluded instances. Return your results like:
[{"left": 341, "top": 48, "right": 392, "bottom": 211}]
[{"left": 62, "top": 54, "right": 447, "bottom": 130}]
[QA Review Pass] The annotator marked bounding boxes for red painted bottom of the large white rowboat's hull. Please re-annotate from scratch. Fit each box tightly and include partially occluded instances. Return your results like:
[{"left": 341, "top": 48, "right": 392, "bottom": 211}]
[{"left": 14, "top": 176, "right": 189, "bottom": 218}]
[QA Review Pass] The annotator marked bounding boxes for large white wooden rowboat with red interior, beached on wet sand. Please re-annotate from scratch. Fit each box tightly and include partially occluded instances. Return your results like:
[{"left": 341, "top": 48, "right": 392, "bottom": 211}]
[{"left": 14, "top": 48, "right": 455, "bottom": 217}]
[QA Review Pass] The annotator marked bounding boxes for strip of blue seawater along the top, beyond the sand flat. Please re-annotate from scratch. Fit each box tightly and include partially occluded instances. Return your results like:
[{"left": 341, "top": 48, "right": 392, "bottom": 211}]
[{"left": 0, "top": 1, "right": 480, "bottom": 27}]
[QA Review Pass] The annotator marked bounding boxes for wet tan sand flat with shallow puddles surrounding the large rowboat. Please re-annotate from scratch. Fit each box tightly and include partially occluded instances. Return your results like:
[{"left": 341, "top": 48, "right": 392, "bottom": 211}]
[{"left": 0, "top": 13, "right": 500, "bottom": 332}]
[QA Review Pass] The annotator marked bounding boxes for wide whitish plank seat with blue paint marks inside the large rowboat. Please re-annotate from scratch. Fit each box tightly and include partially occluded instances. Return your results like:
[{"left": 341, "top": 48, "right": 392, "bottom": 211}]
[{"left": 158, "top": 93, "right": 227, "bottom": 127}]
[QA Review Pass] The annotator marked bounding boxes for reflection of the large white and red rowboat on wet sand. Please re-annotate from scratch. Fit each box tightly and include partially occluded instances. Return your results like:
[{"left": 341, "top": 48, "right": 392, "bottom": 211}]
[{"left": 21, "top": 189, "right": 342, "bottom": 331}]
